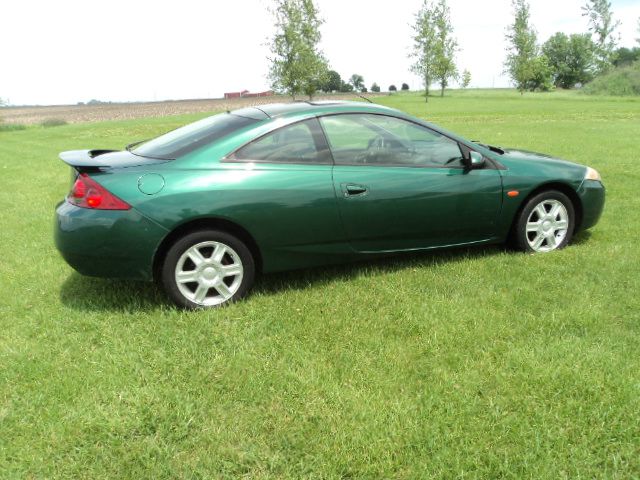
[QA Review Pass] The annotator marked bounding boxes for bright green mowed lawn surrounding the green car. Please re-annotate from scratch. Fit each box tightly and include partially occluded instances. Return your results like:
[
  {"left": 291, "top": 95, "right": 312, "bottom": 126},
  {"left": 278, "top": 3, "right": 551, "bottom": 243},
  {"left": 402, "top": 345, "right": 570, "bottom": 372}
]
[{"left": 0, "top": 91, "right": 640, "bottom": 479}]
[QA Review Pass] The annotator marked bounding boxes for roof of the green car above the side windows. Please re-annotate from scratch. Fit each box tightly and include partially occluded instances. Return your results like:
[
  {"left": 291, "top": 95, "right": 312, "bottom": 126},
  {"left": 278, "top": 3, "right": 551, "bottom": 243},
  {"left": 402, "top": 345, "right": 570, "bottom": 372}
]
[{"left": 231, "top": 100, "right": 402, "bottom": 120}]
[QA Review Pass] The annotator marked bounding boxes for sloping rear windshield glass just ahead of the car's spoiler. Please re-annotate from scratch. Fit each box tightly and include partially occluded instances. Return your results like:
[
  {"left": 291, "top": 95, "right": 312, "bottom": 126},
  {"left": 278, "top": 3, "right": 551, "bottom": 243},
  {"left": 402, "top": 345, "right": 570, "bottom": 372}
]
[{"left": 127, "top": 113, "right": 258, "bottom": 160}]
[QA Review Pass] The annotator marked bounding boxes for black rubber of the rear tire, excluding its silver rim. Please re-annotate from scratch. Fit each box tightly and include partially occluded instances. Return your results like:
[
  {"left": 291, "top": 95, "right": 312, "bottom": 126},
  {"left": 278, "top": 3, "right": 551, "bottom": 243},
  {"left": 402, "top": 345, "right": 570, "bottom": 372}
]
[{"left": 160, "top": 230, "right": 255, "bottom": 309}]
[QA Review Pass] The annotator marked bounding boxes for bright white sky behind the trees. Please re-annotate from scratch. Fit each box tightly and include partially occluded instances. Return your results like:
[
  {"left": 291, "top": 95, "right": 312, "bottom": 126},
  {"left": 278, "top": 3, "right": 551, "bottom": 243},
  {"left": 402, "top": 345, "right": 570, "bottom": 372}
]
[{"left": 0, "top": 0, "right": 640, "bottom": 105}]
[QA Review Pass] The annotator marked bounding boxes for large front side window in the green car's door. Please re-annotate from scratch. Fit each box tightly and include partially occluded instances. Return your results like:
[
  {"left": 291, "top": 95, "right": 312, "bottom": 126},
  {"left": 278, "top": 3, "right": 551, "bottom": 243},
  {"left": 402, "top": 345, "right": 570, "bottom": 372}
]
[{"left": 320, "top": 114, "right": 464, "bottom": 168}]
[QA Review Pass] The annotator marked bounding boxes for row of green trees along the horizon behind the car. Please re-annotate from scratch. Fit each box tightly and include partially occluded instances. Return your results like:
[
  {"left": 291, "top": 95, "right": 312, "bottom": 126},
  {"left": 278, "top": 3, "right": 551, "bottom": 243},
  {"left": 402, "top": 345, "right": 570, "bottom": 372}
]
[{"left": 269, "top": 0, "right": 640, "bottom": 101}]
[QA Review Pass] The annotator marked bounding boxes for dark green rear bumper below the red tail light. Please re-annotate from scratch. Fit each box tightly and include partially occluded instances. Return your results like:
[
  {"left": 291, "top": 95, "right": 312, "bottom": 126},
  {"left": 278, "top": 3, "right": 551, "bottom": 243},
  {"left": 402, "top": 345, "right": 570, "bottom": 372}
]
[{"left": 54, "top": 201, "right": 168, "bottom": 280}]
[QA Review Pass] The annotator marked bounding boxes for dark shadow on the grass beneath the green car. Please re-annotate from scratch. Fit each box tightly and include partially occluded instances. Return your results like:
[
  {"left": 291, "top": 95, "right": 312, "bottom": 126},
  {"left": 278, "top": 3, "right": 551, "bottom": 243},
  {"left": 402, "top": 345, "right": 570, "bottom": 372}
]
[{"left": 60, "top": 246, "right": 505, "bottom": 313}]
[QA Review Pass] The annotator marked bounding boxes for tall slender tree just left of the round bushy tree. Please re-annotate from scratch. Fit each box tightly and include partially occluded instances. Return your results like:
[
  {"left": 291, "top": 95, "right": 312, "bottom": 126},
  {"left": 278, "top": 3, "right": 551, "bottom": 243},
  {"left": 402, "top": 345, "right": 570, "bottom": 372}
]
[{"left": 505, "top": 0, "right": 539, "bottom": 94}]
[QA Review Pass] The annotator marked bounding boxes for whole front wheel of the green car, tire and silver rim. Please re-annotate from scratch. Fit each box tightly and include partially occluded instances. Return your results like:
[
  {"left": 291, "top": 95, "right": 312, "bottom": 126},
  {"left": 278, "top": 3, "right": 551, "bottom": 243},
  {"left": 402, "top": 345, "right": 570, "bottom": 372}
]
[{"left": 513, "top": 190, "right": 576, "bottom": 253}]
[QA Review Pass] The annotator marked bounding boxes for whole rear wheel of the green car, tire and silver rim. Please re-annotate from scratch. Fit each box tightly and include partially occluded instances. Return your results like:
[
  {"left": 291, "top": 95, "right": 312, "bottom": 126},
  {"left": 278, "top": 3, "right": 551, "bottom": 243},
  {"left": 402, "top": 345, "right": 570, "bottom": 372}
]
[{"left": 161, "top": 230, "right": 255, "bottom": 309}]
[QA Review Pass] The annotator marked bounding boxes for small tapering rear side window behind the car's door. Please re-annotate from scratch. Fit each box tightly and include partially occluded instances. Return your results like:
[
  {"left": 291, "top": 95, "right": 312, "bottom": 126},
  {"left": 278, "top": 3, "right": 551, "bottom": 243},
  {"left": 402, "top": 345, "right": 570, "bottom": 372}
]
[{"left": 229, "top": 118, "right": 332, "bottom": 164}]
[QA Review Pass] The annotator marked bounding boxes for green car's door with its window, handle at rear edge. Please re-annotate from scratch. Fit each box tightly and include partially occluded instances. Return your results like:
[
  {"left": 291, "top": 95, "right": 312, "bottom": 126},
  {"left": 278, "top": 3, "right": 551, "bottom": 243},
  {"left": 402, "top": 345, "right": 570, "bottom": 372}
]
[{"left": 320, "top": 114, "right": 502, "bottom": 252}]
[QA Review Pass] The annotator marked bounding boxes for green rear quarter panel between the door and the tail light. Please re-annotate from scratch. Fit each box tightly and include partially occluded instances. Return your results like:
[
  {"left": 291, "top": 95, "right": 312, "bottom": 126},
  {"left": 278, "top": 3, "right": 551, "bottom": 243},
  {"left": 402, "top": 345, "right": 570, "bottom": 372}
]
[{"left": 110, "top": 163, "right": 351, "bottom": 272}]
